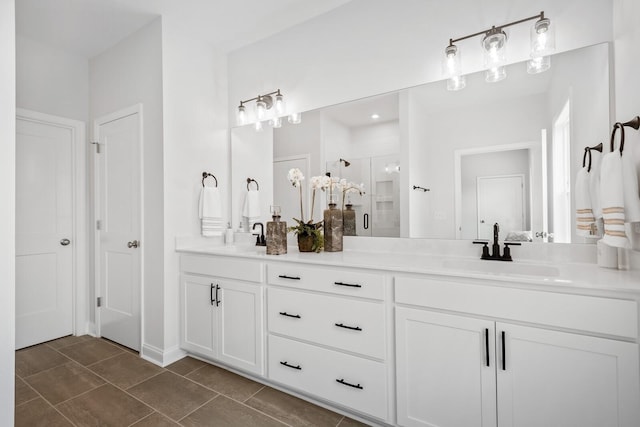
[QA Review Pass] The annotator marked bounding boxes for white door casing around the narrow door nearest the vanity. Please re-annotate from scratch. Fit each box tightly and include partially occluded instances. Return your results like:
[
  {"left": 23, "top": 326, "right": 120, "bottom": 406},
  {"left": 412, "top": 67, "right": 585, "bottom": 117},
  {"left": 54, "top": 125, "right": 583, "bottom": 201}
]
[{"left": 93, "top": 103, "right": 145, "bottom": 351}]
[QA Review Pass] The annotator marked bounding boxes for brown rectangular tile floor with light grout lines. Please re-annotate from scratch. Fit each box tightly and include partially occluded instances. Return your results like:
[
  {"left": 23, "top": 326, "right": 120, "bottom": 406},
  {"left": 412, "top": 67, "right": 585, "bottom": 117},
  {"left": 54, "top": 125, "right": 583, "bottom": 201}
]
[{"left": 15, "top": 336, "right": 364, "bottom": 427}]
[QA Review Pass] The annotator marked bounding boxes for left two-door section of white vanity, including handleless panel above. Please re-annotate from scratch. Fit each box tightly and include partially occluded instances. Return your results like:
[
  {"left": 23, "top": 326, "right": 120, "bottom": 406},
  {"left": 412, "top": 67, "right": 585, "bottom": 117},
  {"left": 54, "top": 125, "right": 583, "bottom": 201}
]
[{"left": 180, "top": 255, "right": 264, "bottom": 375}]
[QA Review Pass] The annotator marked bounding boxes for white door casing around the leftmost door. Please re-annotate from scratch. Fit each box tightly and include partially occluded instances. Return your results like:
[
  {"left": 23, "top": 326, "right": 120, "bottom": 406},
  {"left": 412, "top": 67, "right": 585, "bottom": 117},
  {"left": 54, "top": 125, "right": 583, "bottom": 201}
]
[{"left": 16, "top": 108, "right": 89, "bottom": 335}]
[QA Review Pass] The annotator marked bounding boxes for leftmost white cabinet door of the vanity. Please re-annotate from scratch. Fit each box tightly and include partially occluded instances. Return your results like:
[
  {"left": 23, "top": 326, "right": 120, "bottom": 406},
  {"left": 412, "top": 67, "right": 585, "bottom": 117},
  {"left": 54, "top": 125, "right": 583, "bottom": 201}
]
[{"left": 180, "top": 274, "right": 216, "bottom": 357}]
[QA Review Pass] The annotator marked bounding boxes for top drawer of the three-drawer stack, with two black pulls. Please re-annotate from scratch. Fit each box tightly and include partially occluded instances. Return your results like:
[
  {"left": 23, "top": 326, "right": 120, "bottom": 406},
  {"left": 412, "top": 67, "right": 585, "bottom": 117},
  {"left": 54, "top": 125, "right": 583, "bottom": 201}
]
[{"left": 267, "top": 263, "right": 384, "bottom": 300}]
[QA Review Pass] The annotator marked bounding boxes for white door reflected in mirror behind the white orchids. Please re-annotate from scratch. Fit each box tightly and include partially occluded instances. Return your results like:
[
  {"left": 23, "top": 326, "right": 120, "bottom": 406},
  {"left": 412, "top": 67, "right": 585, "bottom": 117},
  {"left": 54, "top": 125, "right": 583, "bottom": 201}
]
[{"left": 273, "top": 157, "right": 310, "bottom": 226}]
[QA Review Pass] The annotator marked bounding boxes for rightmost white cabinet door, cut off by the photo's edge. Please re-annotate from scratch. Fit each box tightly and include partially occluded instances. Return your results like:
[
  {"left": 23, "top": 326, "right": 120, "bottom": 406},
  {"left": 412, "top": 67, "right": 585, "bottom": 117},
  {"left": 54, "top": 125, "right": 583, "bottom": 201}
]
[{"left": 496, "top": 323, "right": 640, "bottom": 427}]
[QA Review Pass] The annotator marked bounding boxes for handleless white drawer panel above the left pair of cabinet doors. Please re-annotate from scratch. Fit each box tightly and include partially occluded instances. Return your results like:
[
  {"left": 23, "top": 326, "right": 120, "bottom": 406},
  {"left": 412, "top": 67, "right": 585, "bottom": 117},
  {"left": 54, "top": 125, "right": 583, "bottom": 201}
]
[{"left": 180, "top": 255, "right": 263, "bottom": 282}]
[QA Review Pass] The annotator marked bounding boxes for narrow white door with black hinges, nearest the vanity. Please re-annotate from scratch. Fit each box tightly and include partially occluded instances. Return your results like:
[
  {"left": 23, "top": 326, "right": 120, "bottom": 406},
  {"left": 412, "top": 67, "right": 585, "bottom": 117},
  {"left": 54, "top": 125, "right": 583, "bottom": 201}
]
[{"left": 94, "top": 108, "right": 141, "bottom": 351}]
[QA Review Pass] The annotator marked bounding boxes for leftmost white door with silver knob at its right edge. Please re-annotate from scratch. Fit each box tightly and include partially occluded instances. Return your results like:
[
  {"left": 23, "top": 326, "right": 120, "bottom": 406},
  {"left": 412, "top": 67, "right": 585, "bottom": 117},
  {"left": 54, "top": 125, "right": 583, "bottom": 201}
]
[{"left": 15, "top": 118, "right": 75, "bottom": 348}]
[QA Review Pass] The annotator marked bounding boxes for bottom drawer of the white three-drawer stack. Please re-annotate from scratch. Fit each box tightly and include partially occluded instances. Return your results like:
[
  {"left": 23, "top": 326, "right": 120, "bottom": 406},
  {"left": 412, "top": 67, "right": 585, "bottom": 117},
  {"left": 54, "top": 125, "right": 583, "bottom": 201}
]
[{"left": 269, "top": 335, "right": 388, "bottom": 420}]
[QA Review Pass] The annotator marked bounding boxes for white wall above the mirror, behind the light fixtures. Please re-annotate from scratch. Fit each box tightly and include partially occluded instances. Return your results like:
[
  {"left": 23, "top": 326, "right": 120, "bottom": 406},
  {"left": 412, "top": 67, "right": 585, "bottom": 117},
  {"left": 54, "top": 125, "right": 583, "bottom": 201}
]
[{"left": 229, "top": 0, "right": 612, "bottom": 120}]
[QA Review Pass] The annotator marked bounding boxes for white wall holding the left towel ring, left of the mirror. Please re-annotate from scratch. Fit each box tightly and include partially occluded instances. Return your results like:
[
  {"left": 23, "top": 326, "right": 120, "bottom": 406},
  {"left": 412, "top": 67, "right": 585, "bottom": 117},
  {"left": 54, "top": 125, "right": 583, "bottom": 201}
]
[{"left": 161, "top": 21, "right": 231, "bottom": 363}]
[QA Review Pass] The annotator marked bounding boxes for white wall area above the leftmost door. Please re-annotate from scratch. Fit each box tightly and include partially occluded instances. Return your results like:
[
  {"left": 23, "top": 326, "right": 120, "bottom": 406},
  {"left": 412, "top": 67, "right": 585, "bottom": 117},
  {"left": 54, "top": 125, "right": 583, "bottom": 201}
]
[{"left": 16, "top": 36, "right": 89, "bottom": 122}]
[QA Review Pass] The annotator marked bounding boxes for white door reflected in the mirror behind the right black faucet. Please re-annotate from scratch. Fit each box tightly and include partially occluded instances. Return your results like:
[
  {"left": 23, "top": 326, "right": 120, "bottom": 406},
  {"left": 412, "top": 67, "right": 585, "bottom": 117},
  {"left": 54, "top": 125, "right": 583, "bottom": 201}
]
[{"left": 477, "top": 175, "right": 525, "bottom": 240}]
